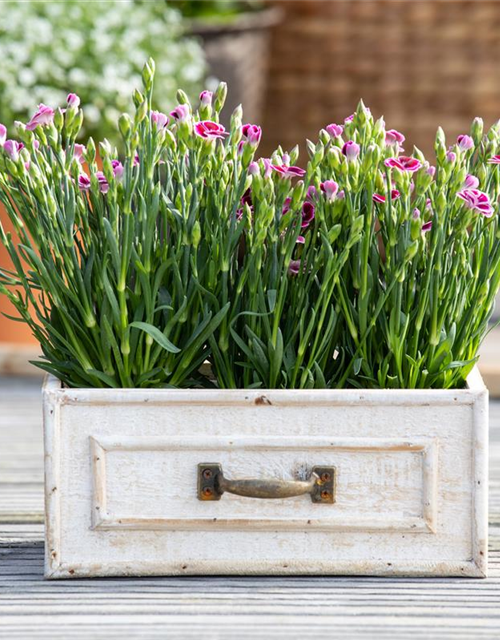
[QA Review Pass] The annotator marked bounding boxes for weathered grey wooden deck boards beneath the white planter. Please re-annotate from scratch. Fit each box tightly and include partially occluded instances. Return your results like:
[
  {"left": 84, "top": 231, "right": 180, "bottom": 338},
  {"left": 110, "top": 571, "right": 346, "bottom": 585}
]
[{"left": 0, "top": 379, "right": 500, "bottom": 640}]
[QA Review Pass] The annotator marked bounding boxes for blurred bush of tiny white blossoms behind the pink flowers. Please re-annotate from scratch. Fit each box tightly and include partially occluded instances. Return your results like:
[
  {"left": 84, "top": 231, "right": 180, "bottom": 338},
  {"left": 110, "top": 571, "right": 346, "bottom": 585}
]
[{"left": 0, "top": 0, "right": 205, "bottom": 139}]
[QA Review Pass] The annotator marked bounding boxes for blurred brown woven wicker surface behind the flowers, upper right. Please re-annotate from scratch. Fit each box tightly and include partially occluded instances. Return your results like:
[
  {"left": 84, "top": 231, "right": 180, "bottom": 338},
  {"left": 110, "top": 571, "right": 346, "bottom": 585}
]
[{"left": 259, "top": 0, "right": 500, "bottom": 159}]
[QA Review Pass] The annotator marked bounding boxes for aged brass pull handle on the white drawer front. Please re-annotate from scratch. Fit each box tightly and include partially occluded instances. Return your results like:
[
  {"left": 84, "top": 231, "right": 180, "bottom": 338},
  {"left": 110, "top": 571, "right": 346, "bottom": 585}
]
[{"left": 198, "top": 463, "right": 335, "bottom": 504}]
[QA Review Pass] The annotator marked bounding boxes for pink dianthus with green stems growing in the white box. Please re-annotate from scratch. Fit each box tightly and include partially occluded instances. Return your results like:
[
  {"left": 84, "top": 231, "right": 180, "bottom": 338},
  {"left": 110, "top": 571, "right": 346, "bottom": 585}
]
[{"left": 0, "top": 61, "right": 500, "bottom": 389}]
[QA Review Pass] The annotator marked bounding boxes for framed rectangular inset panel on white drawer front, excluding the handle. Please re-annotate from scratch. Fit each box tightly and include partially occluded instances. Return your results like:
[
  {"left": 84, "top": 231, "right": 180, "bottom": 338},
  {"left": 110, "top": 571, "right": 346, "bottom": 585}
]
[{"left": 90, "top": 436, "right": 437, "bottom": 533}]
